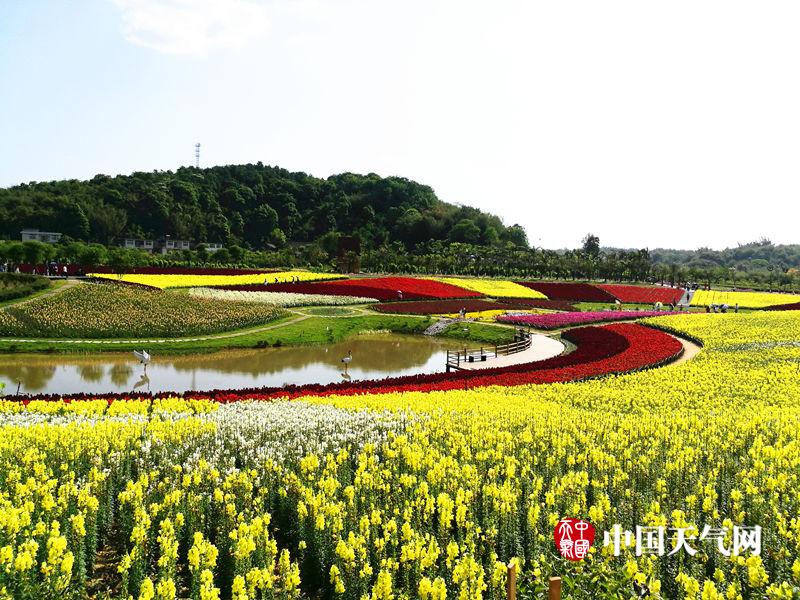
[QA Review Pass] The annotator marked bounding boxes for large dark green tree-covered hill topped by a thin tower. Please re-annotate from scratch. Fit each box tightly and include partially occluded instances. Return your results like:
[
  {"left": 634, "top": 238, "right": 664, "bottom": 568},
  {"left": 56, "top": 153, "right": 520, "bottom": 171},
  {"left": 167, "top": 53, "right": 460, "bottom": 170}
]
[{"left": 0, "top": 162, "right": 527, "bottom": 249}]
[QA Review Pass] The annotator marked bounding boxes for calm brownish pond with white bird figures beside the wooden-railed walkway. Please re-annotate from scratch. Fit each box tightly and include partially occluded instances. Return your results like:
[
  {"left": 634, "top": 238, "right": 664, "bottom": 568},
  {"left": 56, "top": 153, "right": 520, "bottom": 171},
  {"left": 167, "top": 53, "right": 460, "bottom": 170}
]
[{"left": 0, "top": 334, "right": 474, "bottom": 394}]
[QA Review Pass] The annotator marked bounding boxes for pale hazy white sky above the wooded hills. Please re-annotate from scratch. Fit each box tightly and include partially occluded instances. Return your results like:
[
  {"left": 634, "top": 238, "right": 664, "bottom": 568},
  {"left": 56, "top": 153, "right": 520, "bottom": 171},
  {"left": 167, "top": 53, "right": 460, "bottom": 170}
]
[{"left": 0, "top": 0, "right": 800, "bottom": 248}]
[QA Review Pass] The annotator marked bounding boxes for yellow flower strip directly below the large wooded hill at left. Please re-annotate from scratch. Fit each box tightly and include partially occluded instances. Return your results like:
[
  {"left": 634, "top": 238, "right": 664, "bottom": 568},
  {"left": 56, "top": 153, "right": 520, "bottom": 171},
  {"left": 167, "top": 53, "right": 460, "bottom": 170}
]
[{"left": 89, "top": 271, "right": 343, "bottom": 290}]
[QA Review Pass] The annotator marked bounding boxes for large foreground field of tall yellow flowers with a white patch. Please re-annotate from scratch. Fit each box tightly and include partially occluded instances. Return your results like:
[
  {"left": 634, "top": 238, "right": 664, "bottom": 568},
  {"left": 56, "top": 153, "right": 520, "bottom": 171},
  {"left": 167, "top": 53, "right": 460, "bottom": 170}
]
[{"left": 0, "top": 312, "right": 800, "bottom": 600}]
